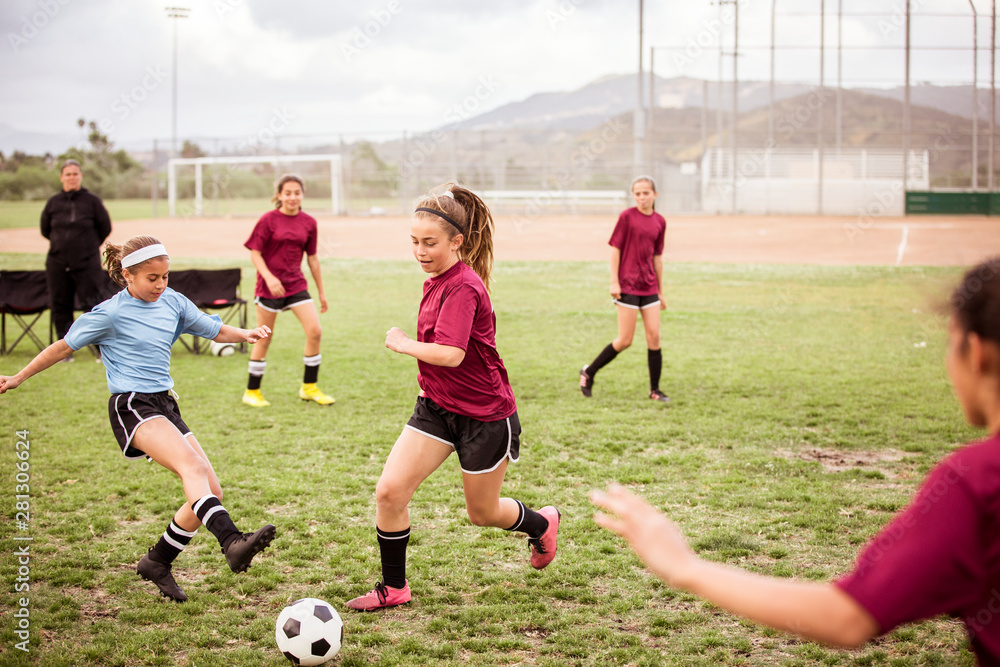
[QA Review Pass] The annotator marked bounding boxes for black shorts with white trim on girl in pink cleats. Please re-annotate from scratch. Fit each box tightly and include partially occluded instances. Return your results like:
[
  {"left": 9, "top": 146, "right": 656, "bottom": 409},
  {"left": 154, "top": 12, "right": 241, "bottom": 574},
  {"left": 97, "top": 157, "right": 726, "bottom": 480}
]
[{"left": 406, "top": 396, "right": 521, "bottom": 475}]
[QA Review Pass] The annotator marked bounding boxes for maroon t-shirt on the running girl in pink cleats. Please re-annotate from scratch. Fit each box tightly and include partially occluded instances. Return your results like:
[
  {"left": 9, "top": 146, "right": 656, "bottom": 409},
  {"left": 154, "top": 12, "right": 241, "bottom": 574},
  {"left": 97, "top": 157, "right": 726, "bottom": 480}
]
[{"left": 417, "top": 262, "right": 517, "bottom": 421}]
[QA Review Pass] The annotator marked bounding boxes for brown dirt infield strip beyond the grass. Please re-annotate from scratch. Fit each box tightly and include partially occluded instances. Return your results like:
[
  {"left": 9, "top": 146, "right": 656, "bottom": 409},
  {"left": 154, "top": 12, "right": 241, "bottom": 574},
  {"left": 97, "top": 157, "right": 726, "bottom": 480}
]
[{"left": 0, "top": 215, "right": 1000, "bottom": 266}]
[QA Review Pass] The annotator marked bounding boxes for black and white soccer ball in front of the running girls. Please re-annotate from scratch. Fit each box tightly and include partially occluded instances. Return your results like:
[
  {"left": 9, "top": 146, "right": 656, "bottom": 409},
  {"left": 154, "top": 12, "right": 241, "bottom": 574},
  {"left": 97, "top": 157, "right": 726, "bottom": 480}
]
[{"left": 274, "top": 598, "right": 344, "bottom": 665}]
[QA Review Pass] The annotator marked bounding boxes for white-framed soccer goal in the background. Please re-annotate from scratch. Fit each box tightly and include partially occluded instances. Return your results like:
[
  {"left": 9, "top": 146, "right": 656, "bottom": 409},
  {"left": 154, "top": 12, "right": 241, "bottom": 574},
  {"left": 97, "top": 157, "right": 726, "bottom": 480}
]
[{"left": 167, "top": 154, "right": 345, "bottom": 218}]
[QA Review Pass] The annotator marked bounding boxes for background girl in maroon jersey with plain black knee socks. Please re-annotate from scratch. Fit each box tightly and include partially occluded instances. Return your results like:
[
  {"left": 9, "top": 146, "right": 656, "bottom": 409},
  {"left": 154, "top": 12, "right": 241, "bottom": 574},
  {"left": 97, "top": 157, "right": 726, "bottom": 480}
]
[{"left": 580, "top": 176, "right": 670, "bottom": 402}]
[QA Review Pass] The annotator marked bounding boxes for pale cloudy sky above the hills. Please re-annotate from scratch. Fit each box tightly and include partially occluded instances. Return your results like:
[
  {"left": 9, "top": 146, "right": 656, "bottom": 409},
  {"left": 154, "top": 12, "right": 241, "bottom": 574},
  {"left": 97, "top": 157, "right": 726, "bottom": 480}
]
[{"left": 0, "top": 0, "right": 992, "bottom": 153}]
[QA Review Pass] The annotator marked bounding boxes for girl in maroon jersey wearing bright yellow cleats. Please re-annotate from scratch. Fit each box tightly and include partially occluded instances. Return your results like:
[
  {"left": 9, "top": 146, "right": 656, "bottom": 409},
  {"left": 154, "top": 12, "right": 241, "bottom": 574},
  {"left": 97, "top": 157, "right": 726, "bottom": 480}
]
[{"left": 243, "top": 174, "right": 335, "bottom": 408}]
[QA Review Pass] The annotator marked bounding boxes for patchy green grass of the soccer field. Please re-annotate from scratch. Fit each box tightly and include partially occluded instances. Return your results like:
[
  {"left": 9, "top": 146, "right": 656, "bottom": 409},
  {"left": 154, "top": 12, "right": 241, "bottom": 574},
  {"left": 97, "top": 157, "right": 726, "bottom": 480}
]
[{"left": 0, "top": 255, "right": 977, "bottom": 666}]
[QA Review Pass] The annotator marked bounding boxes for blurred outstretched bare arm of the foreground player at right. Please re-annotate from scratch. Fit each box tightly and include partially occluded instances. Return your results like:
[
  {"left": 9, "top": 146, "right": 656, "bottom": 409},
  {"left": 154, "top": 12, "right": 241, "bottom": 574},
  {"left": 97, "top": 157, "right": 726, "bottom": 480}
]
[{"left": 590, "top": 484, "right": 879, "bottom": 647}]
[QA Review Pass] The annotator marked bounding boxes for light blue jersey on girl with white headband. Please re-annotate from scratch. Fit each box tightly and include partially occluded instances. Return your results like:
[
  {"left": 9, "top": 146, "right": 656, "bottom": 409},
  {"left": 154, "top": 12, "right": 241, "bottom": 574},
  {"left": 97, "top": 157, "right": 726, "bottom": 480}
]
[{"left": 65, "top": 287, "right": 222, "bottom": 394}]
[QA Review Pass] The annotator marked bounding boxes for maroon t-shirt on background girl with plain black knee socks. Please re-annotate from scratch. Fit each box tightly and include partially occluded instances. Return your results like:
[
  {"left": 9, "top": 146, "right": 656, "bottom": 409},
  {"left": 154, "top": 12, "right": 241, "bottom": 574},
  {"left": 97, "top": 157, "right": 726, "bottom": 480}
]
[{"left": 608, "top": 206, "right": 667, "bottom": 296}]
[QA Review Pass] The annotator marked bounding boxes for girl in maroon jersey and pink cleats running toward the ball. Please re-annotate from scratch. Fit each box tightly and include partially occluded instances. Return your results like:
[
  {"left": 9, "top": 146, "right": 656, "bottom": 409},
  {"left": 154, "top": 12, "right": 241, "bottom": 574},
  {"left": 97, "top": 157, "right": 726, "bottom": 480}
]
[{"left": 347, "top": 183, "right": 559, "bottom": 611}]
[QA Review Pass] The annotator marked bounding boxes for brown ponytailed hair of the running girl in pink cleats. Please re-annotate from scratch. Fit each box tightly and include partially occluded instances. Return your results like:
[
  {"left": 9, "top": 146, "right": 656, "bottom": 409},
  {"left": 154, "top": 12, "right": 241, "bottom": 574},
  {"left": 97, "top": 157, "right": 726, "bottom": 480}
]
[{"left": 416, "top": 183, "right": 494, "bottom": 291}]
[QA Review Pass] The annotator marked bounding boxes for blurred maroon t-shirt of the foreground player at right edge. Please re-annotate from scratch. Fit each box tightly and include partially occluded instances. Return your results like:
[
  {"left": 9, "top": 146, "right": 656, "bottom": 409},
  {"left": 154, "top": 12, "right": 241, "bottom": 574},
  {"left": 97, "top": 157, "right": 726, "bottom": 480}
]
[{"left": 836, "top": 435, "right": 1000, "bottom": 665}]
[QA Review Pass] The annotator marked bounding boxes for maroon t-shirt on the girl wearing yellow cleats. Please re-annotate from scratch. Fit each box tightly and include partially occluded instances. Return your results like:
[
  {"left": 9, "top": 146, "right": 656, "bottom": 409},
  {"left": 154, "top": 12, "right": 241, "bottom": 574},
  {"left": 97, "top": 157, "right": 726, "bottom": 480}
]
[{"left": 243, "top": 209, "right": 318, "bottom": 299}]
